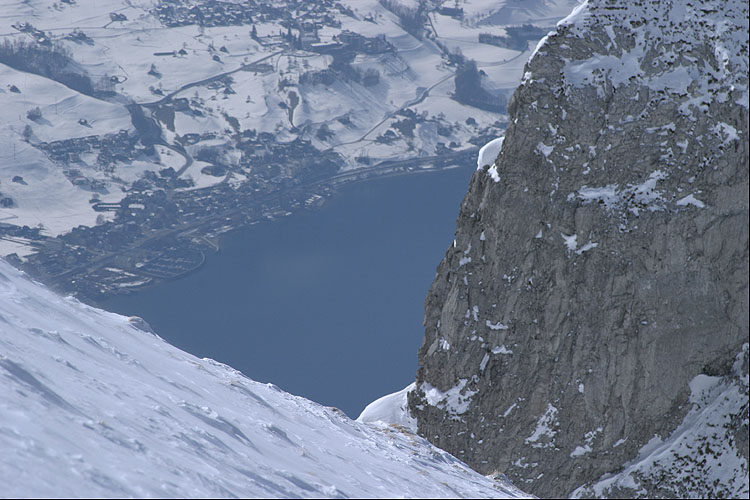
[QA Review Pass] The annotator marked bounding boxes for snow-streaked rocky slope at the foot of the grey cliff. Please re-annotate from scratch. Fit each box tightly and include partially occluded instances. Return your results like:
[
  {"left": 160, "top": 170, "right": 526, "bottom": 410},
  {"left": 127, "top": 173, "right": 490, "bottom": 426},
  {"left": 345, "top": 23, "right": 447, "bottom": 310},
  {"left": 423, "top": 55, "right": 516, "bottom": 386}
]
[{"left": 571, "top": 344, "right": 750, "bottom": 498}]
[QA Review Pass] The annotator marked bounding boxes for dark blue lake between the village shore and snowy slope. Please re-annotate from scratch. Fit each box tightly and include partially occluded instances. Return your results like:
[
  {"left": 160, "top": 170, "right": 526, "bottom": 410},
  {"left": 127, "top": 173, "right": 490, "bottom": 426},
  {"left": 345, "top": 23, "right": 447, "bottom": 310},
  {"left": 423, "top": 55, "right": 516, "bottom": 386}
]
[{"left": 102, "top": 167, "right": 473, "bottom": 418}]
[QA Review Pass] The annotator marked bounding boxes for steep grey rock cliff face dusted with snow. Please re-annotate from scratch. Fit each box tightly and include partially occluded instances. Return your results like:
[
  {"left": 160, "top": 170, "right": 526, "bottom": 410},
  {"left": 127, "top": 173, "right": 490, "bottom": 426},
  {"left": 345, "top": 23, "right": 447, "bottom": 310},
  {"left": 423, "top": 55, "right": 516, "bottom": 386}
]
[{"left": 409, "top": 0, "right": 748, "bottom": 496}]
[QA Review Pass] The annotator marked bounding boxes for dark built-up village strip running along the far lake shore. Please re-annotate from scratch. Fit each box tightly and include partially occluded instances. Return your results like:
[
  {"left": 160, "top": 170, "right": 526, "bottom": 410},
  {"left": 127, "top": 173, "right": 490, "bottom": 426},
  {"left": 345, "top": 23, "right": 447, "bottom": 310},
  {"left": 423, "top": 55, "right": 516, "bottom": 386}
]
[{"left": 13, "top": 144, "right": 476, "bottom": 300}]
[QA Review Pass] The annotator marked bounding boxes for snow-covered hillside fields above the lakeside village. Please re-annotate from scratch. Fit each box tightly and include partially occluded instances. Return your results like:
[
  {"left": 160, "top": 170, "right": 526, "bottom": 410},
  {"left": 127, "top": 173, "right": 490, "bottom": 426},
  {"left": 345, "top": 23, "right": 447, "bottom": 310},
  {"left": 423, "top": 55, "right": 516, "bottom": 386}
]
[{"left": 0, "top": 0, "right": 576, "bottom": 256}]
